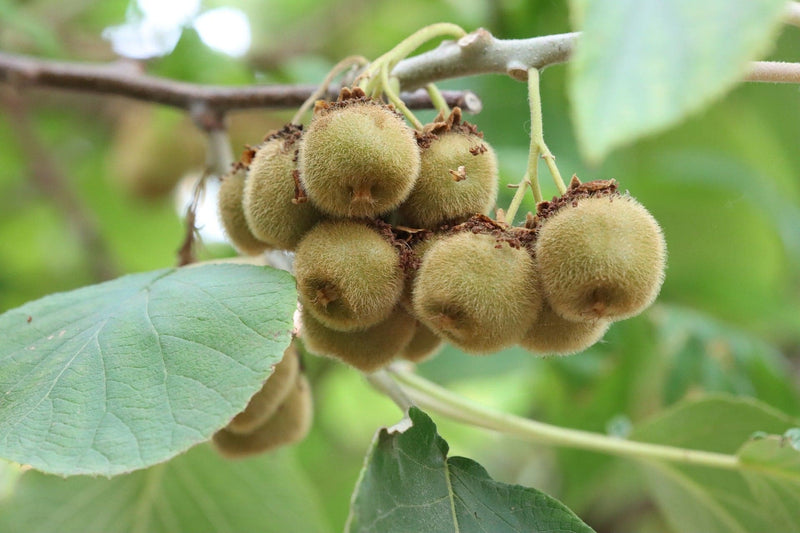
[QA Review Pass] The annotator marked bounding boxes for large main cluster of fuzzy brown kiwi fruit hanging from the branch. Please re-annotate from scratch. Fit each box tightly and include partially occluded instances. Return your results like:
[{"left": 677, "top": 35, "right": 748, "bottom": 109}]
[{"left": 219, "top": 88, "right": 666, "bottom": 372}]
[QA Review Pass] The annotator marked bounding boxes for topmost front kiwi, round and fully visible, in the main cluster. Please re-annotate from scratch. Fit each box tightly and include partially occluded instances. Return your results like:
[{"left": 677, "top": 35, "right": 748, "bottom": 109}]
[{"left": 298, "top": 104, "right": 420, "bottom": 217}]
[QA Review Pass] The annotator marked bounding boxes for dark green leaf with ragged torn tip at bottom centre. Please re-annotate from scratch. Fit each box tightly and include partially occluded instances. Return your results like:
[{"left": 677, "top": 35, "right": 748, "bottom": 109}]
[{"left": 346, "top": 407, "right": 592, "bottom": 533}]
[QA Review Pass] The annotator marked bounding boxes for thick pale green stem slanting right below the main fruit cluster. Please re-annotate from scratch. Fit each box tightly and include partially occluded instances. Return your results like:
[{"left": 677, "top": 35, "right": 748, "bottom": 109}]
[{"left": 389, "top": 367, "right": 745, "bottom": 470}]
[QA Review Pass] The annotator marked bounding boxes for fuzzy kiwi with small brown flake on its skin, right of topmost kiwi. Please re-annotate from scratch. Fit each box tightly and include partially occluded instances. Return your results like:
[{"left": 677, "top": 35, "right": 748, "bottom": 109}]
[{"left": 400, "top": 132, "right": 498, "bottom": 229}]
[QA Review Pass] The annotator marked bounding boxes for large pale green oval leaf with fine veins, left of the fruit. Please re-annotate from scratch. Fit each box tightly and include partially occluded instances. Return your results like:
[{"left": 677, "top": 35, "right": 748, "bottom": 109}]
[{"left": 0, "top": 264, "right": 296, "bottom": 476}]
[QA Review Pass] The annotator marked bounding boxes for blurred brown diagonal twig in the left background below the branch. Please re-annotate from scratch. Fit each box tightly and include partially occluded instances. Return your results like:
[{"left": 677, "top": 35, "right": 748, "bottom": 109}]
[{"left": 0, "top": 91, "right": 118, "bottom": 281}]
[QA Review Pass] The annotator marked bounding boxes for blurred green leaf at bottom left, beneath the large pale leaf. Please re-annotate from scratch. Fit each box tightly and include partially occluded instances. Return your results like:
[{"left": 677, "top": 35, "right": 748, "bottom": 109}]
[{"left": 0, "top": 446, "right": 330, "bottom": 533}]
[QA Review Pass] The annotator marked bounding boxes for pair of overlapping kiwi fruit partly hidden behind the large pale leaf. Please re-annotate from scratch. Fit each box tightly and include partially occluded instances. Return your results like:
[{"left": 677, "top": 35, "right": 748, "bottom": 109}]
[{"left": 212, "top": 342, "right": 312, "bottom": 459}]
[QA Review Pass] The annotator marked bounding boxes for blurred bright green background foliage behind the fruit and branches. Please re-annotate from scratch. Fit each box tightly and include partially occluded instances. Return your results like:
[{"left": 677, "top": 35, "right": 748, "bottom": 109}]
[{"left": 0, "top": 0, "right": 800, "bottom": 532}]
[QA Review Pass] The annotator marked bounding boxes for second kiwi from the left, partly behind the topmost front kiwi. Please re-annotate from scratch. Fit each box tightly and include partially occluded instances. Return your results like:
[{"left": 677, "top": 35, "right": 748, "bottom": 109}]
[{"left": 243, "top": 137, "right": 323, "bottom": 250}]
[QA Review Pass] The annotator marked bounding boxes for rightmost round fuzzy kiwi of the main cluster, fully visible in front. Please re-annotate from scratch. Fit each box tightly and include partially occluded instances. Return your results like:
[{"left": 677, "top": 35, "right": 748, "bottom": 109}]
[{"left": 536, "top": 196, "right": 667, "bottom": 321}]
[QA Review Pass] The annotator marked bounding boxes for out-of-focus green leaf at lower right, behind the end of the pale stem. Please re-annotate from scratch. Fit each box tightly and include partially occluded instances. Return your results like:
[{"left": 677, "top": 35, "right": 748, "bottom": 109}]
[{"left": 631, "top": 396, "right": 800, "bottom": 533}]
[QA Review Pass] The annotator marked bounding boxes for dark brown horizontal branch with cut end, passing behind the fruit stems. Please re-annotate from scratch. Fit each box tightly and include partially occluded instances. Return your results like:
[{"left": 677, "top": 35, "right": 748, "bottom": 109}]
[{"left": 0, "top": 52, "right": 480, "bottom": 123}]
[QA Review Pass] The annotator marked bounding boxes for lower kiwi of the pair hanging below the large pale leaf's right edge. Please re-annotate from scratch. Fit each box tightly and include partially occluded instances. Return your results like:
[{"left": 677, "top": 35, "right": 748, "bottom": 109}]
[{"left": 212, "top": 374, "right": 313, "bottom": 459}]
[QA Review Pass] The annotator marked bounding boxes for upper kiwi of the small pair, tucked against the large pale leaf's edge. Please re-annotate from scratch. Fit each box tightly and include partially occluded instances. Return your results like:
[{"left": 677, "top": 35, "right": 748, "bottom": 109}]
[{"left": 225, "top": 343, "right": 300, "bottom": 433}]
